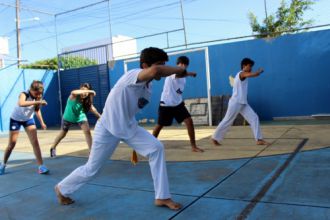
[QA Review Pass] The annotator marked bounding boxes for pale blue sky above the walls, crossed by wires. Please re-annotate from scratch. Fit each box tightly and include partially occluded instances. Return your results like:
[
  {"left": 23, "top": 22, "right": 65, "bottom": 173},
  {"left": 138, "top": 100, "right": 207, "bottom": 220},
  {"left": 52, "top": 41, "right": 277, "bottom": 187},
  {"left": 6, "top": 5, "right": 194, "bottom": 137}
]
[{"left": 0, "top": 0, "right": 330, "bottom": 62}]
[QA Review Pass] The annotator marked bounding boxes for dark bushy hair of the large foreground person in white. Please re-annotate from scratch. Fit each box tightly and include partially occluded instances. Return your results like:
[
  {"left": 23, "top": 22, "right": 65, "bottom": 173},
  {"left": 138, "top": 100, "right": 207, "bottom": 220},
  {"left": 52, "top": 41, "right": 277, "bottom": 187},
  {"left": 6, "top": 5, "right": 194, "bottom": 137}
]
[{"left": 140, "top": 47, "right": 168, "bottom": 68}]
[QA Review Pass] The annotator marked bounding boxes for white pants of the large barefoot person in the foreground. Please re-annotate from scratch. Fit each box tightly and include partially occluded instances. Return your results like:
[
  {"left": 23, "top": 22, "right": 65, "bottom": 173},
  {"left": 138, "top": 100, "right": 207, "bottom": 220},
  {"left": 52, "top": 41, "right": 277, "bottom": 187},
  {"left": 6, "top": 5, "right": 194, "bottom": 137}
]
[{"left": 58, "top": 122, "right": 171, "bottom": 199}]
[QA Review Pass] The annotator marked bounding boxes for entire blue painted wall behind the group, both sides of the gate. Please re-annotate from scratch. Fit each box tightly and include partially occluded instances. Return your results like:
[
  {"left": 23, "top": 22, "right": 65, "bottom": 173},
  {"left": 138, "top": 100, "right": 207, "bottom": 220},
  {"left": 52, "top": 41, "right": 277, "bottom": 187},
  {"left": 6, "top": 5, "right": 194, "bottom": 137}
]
[{"left": 0, "top": 30, "right": 330, "bottom": 131}]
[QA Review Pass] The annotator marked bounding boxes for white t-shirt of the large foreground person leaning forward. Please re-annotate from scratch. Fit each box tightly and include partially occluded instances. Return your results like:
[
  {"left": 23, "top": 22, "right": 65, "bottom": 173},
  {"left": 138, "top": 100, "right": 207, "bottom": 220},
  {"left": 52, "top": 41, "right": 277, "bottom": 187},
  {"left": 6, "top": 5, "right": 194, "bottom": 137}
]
[{"left": 100, "top": 69, "right": 151, "bottom": 139}]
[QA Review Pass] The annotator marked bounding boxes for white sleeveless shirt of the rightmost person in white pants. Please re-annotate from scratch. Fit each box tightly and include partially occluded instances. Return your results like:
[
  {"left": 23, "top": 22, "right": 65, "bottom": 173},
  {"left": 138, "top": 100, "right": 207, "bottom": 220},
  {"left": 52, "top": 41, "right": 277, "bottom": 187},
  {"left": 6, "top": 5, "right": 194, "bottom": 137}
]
[{"left": 231, "top": 71, "right": 248, "bottom": 104}]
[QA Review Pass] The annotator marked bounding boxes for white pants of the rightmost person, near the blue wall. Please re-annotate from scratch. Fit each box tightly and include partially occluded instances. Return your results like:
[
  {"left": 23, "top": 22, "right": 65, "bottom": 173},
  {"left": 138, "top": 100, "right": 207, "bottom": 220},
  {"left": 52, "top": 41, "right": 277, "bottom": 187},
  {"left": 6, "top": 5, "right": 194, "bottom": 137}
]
[{"left": 212, "top": 100, "right": 262, "bottom": 142}]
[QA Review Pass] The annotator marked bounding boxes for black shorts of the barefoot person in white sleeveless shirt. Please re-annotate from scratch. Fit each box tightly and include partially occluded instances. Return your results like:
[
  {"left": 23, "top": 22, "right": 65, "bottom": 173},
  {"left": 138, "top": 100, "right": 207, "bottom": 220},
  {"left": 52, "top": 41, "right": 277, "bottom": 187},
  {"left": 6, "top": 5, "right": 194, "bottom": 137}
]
[{"left": 158, "top": 102, "right": 191, "bottom": 126}]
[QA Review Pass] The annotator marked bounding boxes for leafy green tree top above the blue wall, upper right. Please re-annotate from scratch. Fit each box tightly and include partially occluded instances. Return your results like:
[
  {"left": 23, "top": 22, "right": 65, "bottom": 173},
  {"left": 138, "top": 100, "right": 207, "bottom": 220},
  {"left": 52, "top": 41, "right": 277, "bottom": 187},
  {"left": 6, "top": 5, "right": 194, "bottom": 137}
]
[{"left": 248, "top": 0, "right": 315, "bottom": 38}]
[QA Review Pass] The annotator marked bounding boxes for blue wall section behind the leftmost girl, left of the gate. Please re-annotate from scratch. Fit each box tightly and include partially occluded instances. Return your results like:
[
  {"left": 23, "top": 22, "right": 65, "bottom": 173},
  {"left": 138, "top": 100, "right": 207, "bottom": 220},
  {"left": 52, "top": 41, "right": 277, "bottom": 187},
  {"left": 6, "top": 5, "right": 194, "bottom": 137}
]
[{"left": 0, "top": 67, "right": 60, "bottom": 131}]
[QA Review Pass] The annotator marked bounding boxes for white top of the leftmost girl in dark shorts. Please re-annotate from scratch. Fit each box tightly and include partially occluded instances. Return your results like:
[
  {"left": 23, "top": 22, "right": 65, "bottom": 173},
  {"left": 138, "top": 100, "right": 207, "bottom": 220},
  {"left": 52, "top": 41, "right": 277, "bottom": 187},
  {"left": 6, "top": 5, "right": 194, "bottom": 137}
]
[{"left": 10, "top": 91, "right": 36, "bottom": 121}]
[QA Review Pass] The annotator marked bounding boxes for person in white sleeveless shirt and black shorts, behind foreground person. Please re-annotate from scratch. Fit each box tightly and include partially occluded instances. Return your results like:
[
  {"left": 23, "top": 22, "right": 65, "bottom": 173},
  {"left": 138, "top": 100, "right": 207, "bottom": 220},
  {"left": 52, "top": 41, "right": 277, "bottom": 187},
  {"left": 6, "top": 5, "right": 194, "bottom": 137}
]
[{"left": 152, "top": 56, "right": 203, "bottom": 152}]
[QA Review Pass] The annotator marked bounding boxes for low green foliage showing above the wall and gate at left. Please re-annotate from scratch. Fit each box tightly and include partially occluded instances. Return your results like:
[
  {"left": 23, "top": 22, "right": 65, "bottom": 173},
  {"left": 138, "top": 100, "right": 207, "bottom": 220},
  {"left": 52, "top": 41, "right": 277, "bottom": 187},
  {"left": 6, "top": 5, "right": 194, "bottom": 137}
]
[{"left": 20, "top": 56, "right": 97, "bottom": 70}]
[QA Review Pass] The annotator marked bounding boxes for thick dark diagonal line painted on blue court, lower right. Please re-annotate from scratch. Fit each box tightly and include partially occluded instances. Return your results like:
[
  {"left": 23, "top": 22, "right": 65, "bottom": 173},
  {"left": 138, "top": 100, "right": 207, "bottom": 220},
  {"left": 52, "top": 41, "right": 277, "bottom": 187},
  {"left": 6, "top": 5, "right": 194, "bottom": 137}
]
[{"left": 237, "top": 138, "right": 308, "bottom": 220}]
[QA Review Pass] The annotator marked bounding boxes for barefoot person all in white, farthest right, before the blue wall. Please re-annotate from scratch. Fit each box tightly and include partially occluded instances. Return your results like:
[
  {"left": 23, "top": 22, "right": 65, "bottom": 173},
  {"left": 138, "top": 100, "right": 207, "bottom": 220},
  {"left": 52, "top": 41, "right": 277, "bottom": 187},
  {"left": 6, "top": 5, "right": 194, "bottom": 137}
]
[{"left": 211, "top": 58, "right": 267, "bottom": 145}]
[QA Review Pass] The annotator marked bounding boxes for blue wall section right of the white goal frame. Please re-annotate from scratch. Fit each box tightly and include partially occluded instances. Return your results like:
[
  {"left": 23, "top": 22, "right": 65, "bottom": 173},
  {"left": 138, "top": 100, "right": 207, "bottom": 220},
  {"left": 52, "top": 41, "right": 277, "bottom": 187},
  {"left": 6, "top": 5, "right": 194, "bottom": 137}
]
[{"left": 209, "top": 30, "right": 330, "bottom": 120}]
